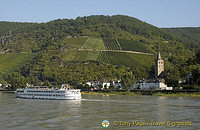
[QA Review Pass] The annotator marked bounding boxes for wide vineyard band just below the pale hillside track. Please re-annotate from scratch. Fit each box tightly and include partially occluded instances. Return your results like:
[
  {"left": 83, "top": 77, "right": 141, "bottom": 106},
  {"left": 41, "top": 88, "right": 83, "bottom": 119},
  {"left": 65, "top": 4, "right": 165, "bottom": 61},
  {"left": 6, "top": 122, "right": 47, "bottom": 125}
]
[{"left": 63, "top": 50, "right": 155, "bottom": 67}]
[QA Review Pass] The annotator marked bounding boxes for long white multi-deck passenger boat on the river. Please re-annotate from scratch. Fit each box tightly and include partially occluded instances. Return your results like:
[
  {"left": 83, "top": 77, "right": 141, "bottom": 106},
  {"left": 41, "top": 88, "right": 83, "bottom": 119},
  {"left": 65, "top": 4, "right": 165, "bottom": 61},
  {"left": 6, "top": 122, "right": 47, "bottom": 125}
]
[{"left": 15, "top": 84, "right": 81, "bottom": 100}]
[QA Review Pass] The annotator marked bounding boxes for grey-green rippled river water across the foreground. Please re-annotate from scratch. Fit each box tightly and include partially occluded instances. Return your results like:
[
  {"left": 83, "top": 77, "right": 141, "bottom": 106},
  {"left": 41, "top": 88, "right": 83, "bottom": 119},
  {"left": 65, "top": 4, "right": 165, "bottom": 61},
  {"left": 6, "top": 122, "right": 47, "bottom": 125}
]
[{"left": 0, "top": 93, "right": 200, "bottom": 130}]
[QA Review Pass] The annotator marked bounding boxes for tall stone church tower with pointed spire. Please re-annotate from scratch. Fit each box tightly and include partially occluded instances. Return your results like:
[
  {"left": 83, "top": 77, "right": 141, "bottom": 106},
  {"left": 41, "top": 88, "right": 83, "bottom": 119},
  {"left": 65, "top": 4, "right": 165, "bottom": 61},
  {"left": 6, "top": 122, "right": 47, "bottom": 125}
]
[{"left": 155, "top": 52, "right": 164, "bottom": 79}]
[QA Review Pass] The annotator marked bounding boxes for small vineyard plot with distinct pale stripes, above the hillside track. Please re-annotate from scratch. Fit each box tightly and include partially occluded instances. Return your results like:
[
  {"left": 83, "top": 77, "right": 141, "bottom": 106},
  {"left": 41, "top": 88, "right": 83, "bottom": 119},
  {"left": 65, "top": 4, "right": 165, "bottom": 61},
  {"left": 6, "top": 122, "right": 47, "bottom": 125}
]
[{"left": 103, "top": 39, "right": 121, "bottom": 50}]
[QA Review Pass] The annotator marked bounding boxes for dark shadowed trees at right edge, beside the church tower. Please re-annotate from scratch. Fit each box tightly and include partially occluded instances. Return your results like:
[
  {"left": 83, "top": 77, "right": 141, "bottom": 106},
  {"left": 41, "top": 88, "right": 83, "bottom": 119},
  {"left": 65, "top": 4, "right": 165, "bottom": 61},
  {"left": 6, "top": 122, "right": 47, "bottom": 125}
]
[{"left": 165, "top": 50, "right": 200, "bottom": 89}]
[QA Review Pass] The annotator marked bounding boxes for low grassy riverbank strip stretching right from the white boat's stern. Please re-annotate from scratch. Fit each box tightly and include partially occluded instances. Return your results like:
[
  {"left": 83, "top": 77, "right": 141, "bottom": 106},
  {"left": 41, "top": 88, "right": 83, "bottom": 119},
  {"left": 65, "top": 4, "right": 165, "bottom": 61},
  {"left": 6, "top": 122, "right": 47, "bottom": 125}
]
[{"left": 81, "top": 91, "right": 200, "bottom": 97}]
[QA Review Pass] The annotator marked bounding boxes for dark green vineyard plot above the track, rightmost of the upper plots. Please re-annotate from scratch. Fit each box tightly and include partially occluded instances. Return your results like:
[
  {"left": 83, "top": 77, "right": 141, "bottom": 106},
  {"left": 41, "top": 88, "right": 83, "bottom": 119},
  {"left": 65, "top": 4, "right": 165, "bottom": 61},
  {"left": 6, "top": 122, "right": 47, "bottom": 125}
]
[{"left": 118, "top": 39, "right": 150, "bottom": 53}]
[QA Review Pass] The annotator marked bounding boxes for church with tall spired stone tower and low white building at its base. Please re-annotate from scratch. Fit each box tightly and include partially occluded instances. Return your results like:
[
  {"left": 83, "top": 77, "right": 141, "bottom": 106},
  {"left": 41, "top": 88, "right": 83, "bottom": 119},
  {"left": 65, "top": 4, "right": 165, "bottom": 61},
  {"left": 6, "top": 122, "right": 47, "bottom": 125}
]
[{"left": 137, "top": 52, "right": 172, "bottom": 90}]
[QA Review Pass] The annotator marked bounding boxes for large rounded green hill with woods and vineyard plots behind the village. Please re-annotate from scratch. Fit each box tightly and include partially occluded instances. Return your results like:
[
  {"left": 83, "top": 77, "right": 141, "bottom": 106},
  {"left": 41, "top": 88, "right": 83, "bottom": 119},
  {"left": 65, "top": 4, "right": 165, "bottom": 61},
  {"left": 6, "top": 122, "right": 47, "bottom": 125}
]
[{"left": 0, "top": 15, "right": 199, "bottom": 88}]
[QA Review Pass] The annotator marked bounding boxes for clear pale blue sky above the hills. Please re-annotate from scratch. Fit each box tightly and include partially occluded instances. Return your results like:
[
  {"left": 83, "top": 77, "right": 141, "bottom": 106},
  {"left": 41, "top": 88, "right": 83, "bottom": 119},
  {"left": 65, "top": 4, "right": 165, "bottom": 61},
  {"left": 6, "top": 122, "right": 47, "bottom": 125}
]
[{"left": 0, "top": 0, "right": 200, "bottom": 27}]
